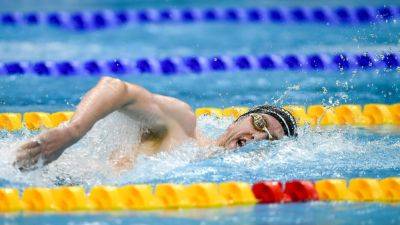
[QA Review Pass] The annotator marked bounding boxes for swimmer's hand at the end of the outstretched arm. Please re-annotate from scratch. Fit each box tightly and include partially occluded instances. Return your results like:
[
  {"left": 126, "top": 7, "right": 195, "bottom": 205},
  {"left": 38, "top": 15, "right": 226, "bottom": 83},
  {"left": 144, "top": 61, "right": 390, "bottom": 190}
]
[{"left": 13, "top": 127, "right": 76, "bottom": 171}]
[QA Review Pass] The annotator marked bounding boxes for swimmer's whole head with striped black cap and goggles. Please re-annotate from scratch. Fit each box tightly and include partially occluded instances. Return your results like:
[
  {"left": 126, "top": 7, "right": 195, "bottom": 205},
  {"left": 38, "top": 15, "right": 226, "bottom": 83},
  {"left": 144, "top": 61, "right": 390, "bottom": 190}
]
[{"left": 217, "top": 105, "right": 297, "bottom": 149}]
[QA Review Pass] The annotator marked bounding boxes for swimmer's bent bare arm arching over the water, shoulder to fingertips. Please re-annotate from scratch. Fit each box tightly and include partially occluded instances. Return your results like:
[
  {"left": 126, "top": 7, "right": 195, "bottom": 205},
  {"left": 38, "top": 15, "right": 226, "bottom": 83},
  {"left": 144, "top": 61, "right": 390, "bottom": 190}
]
[{"left": 14, "top": 77, "right": 158, "bottom": 171}]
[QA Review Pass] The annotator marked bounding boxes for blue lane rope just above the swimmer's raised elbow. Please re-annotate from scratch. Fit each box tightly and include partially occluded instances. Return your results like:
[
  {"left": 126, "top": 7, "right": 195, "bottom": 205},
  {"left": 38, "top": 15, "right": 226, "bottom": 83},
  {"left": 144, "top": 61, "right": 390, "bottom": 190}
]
[{"left": 0, "top": 52, "right": 400, "bottom": 76}]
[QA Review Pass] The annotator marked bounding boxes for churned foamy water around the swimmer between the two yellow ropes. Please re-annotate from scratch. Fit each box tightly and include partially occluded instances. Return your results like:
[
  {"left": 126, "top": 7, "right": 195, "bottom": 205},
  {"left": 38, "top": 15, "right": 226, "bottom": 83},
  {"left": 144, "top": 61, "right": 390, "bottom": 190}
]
[{"left": 0, "top": 113, "right": 400, "bottom": 187}]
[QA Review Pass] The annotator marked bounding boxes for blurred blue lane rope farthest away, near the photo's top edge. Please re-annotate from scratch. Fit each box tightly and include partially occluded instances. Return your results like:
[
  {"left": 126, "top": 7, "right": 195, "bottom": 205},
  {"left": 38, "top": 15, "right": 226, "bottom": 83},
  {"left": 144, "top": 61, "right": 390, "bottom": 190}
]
[{"left": 0, "top": 6, "right": 400, "bottom": 31}]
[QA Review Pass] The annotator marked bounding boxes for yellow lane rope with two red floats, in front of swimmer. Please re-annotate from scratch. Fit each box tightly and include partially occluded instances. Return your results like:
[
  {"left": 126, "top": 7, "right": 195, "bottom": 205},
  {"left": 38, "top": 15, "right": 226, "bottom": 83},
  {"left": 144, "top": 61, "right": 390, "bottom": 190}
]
[{"left": 0, "top": 177, "right": 400, "bottom": 213}]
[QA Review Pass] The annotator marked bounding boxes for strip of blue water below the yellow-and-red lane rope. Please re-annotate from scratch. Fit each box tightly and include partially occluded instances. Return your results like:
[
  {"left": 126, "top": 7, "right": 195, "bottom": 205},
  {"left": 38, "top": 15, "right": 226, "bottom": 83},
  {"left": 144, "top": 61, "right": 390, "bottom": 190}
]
[{"left": 2, "top": 203, "right": 400, "bottom": 225}]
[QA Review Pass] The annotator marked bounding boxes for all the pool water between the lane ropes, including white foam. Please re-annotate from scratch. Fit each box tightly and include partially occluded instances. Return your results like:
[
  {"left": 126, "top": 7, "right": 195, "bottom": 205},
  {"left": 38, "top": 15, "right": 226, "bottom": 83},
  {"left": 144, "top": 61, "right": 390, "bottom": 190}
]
[{"left": 0, "top": 0, "right": 400, "bottom": 224}]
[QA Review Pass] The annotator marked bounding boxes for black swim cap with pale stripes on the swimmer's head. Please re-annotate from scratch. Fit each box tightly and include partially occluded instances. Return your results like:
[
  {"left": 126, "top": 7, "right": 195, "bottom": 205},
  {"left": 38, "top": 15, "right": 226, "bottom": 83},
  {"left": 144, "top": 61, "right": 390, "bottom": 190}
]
[{"left": 238, "top": 105, "right": 297, "bottom": 137}]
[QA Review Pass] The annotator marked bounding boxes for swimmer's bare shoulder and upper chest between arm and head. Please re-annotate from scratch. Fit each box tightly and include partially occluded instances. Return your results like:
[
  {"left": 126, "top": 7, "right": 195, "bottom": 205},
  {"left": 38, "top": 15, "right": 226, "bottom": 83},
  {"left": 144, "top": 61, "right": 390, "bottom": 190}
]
[{"left": 112, "top": 95, "right": 196, "bottom": 164}]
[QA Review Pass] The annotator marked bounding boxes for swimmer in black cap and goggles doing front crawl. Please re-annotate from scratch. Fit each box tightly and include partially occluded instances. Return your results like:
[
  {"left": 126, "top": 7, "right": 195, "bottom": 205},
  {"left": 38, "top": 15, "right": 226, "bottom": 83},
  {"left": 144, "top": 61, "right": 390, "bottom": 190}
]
[{"left": 14, "top": 77, "right": 297, "bottom": 171}]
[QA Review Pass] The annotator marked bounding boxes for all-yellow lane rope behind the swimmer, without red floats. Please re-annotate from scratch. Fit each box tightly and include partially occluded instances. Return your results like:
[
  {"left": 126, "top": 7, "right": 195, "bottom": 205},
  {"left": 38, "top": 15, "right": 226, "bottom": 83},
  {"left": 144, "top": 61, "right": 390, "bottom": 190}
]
[{"left": 0, "top": 103, "right": 400, "bottom": 131}]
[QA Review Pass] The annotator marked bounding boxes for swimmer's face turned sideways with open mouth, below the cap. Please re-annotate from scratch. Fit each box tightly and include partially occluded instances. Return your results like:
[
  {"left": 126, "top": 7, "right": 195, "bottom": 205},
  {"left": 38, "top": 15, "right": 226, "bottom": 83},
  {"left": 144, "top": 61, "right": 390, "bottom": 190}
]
[{"left": 217, "top": 114, "right": 284, "bottom": 149}]
